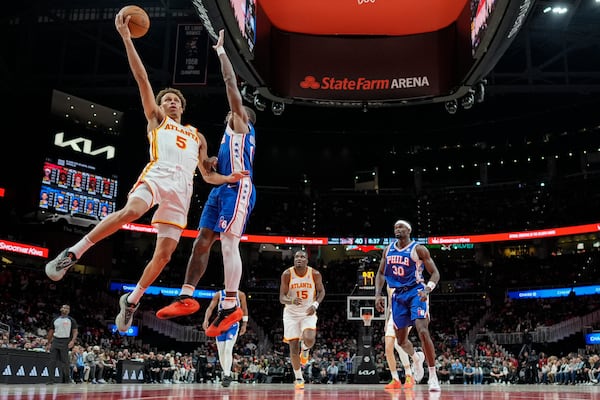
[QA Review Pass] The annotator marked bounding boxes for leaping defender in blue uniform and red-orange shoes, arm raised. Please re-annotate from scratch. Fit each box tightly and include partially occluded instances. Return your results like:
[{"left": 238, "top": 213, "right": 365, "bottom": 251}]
[{"left": 156, "top": 30, "right": 256, "bottom": 337}]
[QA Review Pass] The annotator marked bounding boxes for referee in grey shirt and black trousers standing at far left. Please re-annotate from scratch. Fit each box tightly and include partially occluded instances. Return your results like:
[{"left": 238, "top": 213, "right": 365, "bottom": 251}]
[{"left": 46, "top": 304, "right": 78, "bottom": 385}]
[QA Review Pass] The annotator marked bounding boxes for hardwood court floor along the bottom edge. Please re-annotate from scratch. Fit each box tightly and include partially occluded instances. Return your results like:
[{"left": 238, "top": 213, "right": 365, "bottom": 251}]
[{"left": 0, "top": 384, "right": 600, "bottom": 400}]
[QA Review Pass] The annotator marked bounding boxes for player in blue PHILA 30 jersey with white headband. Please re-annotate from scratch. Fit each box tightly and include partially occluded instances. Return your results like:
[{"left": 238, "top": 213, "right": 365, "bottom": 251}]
[{"left": 375, "top": 220, "right": 440, "bottom": 392}]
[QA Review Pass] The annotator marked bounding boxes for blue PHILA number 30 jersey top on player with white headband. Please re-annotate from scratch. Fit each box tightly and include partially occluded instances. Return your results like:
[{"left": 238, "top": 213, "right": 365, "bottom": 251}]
[{"left": 383, "top": 240, "right": 423, "bottom": 288}]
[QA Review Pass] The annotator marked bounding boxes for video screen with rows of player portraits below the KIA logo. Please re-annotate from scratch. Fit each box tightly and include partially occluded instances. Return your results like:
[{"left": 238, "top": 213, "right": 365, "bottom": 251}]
[{"left": 39, "top": 159, "right": 119, "bottom": 219}]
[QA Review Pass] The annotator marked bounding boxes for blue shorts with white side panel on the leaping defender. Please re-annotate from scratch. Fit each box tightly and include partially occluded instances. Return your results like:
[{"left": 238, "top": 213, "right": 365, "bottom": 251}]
[{"left": 199, "top": 182, "right": 256, "bottom": 237}]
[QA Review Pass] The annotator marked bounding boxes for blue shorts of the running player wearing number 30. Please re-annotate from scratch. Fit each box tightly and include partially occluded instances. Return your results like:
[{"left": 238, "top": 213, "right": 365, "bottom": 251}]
[{"left": 391, "top": 283, "right": 429, "bottom": 329}]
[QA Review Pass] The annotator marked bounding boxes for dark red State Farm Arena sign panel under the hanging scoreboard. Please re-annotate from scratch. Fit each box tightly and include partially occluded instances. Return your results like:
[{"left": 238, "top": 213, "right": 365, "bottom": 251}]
[{"left": 272, "top": 25, "right": 459, "bottom": 101}]
